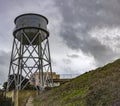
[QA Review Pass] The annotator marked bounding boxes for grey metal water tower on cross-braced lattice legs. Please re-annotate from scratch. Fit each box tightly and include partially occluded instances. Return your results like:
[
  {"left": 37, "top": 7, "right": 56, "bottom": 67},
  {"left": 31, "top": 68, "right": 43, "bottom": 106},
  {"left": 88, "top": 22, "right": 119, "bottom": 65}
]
[{"left": 7, "top": 13, "right": 52, "bottom": 90}]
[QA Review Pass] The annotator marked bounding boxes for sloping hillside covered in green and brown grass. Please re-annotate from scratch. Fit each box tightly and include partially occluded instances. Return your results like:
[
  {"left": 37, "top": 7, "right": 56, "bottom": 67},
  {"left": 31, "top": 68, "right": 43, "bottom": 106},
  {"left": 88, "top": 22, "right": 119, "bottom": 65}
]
[{"left": 34, "top": 59, "right": 120, "bottom": 106}]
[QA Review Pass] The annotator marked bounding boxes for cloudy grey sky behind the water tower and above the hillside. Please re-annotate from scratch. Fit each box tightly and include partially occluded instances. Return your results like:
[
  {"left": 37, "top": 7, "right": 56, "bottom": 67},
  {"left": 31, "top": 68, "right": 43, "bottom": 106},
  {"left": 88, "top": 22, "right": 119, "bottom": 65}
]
[{"left": 0, "top": 0, "right": 120, "bottom": 83}]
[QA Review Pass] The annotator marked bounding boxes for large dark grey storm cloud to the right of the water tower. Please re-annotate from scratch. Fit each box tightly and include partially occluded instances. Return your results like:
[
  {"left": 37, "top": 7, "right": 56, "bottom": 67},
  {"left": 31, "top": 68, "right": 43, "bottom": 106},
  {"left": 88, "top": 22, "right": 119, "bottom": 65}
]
[{"left": 56, "top": 0, "right": 120, "bottom": 65}]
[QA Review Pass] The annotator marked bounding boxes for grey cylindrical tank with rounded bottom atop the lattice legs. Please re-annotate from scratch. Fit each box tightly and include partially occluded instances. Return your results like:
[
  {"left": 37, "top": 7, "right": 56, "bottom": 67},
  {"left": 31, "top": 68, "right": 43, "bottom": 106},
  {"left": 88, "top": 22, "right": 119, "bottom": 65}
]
[{"left": 13, "top": 13, "right": 49, "bottom": 45}]
